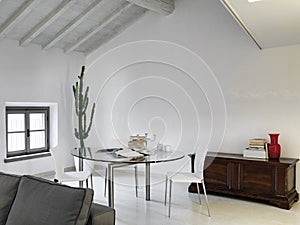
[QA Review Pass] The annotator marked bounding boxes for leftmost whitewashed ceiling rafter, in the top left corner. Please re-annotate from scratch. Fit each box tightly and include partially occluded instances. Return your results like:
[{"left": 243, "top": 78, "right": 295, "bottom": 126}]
[{"left": 0, "top": 0, "right": 41, "bottom": 36}]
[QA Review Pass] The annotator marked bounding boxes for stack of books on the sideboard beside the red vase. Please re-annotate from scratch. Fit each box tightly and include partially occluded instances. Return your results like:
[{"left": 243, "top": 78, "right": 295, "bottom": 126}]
[{"left": 243, "top": 138, "right": 268, "bottom": 159}]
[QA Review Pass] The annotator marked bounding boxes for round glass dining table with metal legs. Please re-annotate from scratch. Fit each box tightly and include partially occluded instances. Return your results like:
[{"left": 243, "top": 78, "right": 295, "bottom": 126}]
[{"left": 71, "top": 147, "right": 185, "bottom": 208}]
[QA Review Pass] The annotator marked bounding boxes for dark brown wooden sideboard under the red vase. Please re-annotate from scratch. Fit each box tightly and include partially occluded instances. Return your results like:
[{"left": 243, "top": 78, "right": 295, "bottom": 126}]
[{"left": 189, "top": 153, "right": 299, "bottom": 209}]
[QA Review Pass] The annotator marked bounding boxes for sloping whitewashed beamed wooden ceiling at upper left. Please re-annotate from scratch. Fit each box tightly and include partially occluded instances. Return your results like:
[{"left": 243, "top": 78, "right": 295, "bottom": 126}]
[{"left": 0, "top": 0, "right": 175, "bottom": 55}]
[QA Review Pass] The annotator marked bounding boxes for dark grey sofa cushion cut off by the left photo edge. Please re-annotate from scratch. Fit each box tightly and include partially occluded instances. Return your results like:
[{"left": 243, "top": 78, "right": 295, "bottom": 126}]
[{"left": 0, "top": 172, "right": 21, "bottom": 225}]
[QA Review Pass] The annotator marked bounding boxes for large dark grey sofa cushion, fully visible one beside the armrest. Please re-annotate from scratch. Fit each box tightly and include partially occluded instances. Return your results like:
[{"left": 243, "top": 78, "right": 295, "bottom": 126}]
[{"left": 6, "top": 176, "right": 94, "bottom": 225}]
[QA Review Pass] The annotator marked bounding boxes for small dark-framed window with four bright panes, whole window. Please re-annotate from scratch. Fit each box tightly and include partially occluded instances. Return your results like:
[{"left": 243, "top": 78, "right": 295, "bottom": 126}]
[{"left": 6, "top": 107, "right": 49, "bottom": 157}]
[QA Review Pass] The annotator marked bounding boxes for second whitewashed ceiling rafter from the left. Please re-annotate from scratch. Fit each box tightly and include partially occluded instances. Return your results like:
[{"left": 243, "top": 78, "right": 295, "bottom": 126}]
[{"left": 19, "top": 0, "right": 73, "bottom": 46}]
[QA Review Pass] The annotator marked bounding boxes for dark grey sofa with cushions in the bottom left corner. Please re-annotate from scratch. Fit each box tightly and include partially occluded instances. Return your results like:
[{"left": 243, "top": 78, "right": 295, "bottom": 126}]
[{"left": 0, "top": 172, "right": 115, "bottom": 225}]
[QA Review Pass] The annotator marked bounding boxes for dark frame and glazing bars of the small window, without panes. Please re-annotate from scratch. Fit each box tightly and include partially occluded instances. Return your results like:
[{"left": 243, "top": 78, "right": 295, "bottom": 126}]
[{"left": 5, "top": 106, "right": 50, "bottom": 158}]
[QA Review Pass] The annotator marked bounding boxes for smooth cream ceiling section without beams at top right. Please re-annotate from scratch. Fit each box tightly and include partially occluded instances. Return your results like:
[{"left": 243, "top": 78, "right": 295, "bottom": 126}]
[{"left": 220, "top": 0, "right": 300, "bottom": 49}]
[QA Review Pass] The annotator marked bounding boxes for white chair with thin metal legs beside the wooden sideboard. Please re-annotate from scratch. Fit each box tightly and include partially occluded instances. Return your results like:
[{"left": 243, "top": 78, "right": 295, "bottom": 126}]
[{"left": 165, "top": 150, "right": 210, "bottom": 217}]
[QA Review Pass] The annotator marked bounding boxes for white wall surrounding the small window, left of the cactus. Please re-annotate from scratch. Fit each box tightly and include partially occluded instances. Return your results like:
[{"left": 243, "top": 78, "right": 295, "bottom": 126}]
[{"left": 0, "top": 40, "right": 85, "bottom": 174}]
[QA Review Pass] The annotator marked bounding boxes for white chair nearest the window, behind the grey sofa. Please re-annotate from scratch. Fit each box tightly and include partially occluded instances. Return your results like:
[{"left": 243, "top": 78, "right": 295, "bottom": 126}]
[{"left": 50, "top": 148, "right": 94, "bottom": 188}]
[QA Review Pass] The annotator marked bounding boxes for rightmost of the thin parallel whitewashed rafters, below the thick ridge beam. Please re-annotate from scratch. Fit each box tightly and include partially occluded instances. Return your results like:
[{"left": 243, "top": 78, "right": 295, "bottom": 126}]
[{"left": 65, "top": 2, "right": 132, "bottom": 53}]
